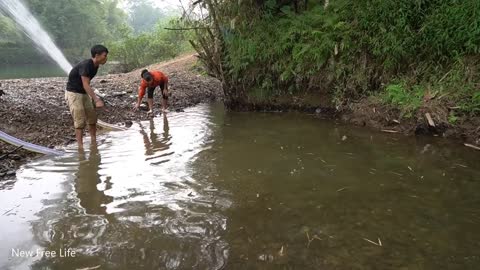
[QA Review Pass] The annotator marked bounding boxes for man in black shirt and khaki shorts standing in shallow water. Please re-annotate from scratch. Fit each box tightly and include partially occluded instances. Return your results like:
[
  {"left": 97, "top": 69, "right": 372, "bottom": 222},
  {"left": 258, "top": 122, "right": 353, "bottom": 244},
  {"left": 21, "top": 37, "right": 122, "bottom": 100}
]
[{"left": 65, "top": 45, "right": 108, "bottom": 148}]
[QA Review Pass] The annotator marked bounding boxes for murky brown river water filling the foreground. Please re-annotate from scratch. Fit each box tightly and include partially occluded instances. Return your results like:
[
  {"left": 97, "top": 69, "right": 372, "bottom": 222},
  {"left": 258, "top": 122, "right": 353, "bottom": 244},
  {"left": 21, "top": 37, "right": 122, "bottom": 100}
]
[{"left": 0, "top": 104, "right": 480, "bottom": 269}]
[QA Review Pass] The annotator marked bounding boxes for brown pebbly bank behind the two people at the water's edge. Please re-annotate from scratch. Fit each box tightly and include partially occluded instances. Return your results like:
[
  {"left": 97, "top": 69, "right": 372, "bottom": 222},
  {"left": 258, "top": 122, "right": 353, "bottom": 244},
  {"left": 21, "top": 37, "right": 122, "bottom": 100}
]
[{"left": 0, "top": 55, "right": 223, "bottom": 179}]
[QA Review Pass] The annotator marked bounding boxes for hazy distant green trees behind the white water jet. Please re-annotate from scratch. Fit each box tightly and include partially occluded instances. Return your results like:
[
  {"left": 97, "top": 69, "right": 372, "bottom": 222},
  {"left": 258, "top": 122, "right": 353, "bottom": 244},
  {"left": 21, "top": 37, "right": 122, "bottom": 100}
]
[{"left": 0, "top": 0, "right": 191, "bottom": 71}]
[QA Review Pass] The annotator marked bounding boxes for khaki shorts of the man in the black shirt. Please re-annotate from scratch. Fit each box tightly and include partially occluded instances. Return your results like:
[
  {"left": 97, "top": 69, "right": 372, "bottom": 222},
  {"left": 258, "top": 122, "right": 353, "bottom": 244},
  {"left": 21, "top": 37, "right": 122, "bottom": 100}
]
[{"left": 65, "top": 91, "right": 97, "bottom": 128}]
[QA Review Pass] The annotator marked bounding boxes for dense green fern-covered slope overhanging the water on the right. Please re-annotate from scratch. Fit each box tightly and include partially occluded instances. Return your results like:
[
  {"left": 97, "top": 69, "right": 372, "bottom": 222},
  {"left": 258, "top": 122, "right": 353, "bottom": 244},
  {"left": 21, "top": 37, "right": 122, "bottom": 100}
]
[{"left": 190, "top": 0, "right": 480, "bottom": 116}]
